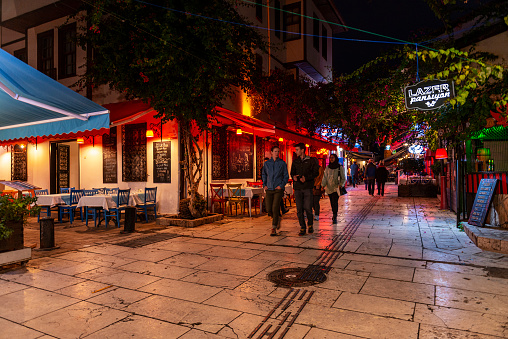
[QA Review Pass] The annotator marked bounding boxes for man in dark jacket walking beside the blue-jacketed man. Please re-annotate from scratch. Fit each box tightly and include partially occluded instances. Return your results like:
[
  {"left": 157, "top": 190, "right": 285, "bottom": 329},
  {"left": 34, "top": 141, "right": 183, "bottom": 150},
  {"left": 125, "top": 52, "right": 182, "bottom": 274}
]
[{"left": 291, "top": 143, "right": 319, "bottom": 235}]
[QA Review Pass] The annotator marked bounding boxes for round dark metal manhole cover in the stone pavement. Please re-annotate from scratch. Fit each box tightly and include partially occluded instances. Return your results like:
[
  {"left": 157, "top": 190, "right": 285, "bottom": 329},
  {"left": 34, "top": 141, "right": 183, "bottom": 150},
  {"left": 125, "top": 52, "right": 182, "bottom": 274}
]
[{"left": 267, "top": 267, "right": 326, "bottom": 287}]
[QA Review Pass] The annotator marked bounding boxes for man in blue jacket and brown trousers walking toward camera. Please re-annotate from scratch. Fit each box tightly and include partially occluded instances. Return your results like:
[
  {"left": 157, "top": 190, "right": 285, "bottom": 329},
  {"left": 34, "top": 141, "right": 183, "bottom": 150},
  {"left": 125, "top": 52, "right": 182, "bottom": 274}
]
[{"left": 261, "top": 146, "right": 289, "bottom": 236}]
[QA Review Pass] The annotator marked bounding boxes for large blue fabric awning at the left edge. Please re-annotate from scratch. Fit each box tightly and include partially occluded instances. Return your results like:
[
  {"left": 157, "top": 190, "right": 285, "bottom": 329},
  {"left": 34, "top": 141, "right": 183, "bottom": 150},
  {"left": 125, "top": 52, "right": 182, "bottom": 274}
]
[{"left": 0, "top": 49, "right": 109, "bottom": 141}]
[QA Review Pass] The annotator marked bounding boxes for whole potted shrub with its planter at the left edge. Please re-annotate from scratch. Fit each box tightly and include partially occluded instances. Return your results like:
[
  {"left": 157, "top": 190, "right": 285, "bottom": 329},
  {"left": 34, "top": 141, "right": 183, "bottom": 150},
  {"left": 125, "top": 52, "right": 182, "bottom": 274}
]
[{"left": 0, "top": 195, "right": 40, "bottom": 265}]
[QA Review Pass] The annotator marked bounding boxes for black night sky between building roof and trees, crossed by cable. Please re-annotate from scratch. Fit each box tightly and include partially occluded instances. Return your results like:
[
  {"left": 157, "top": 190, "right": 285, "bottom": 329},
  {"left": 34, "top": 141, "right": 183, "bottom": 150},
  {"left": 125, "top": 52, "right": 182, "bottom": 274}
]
[{"left": 333, "top": 0, "right": 443, "bottom": 74}]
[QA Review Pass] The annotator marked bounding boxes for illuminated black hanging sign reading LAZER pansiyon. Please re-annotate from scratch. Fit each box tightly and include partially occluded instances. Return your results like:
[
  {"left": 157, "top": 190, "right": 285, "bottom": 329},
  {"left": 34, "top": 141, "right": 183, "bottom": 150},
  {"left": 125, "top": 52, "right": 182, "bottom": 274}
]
[{"left": 404, "top": 80, "right": 455, "bottom": 111}]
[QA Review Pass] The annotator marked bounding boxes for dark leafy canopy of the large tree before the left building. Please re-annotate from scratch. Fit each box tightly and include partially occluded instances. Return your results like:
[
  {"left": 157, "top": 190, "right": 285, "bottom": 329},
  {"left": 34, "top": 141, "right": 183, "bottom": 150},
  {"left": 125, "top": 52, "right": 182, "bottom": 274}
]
[{"left": 78, "top": 0, "right": 265, "bottom": 128}]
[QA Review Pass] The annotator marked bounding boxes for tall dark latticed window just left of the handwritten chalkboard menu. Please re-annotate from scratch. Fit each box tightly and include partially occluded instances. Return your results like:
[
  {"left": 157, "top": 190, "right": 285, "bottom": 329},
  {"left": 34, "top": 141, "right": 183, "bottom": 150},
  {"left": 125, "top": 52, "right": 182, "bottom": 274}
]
[{"left": 122, "top": 122, "right": 148, "bottom": 182}]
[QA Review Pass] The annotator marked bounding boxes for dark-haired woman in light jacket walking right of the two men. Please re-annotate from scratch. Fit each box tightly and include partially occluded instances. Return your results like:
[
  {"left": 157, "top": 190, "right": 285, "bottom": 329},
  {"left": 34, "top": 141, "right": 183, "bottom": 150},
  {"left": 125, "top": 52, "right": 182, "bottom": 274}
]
[{"left": 321, "top": 154, "right": 346, "bottom": 224}]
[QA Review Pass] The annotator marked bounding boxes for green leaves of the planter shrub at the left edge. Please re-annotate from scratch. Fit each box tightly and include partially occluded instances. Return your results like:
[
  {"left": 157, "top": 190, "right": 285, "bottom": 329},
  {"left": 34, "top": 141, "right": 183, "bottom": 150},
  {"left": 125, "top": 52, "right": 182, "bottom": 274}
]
[{"left": 0, "top": 195, "right": 40, "bottom": 240}]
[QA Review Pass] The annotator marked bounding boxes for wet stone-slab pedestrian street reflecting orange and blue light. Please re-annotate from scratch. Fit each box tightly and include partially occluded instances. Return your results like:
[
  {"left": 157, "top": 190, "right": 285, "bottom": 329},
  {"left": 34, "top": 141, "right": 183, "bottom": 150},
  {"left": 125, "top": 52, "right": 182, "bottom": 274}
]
[{"left": 0, "top": 184, "right": 508, "bottom": 339}]
